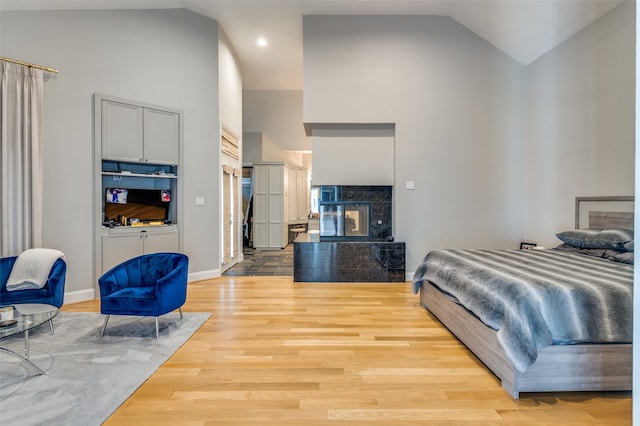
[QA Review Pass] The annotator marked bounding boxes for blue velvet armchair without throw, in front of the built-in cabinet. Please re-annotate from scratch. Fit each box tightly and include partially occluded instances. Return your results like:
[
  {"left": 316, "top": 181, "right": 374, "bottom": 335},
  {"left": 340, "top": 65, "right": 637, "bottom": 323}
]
[{"left": 98, "top": 253, "right": 189, "bottom": 339}]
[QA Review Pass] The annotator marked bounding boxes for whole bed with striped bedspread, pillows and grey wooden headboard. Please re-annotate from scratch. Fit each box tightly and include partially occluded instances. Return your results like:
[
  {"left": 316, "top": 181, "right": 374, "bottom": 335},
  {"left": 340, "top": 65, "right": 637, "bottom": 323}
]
[{"left": 413, "top": 197, "right": 633, "bottom": 399}]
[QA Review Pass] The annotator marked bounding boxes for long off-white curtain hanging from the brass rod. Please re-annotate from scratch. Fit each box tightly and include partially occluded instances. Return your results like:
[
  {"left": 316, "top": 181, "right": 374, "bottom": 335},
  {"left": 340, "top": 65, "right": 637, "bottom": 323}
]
[{"left": 0, "top": 61, "right": 43, "bottom": 257}]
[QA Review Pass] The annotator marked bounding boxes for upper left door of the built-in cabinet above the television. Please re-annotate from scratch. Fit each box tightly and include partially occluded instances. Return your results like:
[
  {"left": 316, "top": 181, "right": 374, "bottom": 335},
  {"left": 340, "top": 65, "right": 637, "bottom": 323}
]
[{"left": 102, "top": 99, "right": 144, "bottom": 162}]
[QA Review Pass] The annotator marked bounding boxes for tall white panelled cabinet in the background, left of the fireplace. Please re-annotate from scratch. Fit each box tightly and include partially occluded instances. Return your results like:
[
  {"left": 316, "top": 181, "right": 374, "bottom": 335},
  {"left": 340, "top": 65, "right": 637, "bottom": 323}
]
[{"left": 252, "top": 163, "right": 289, "bottom": 249}]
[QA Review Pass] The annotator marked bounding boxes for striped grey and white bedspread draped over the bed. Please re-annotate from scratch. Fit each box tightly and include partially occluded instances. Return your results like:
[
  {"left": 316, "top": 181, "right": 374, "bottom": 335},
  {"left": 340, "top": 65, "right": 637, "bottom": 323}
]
[{"left": 413, "top": 249, "right": 633, "bottom": 371}]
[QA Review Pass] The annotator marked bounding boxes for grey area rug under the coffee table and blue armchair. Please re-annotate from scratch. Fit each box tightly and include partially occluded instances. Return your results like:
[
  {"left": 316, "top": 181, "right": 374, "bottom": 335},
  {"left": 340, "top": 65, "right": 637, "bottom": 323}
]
[{"left": 0, "top": 311, "right": 210, "bottom": 426}]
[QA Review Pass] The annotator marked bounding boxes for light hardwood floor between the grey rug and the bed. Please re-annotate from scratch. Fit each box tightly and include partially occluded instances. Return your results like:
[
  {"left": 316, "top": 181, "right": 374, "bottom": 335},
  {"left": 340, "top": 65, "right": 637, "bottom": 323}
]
[{"left": 63, "top": 277, "right": 631, "bottom": 426}]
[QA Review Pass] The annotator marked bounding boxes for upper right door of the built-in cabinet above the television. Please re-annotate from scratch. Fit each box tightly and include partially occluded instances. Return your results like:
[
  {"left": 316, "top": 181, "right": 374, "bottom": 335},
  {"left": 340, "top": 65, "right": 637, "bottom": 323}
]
[{"left": 144, "top": 108, "right": 180, "bottom": 164}]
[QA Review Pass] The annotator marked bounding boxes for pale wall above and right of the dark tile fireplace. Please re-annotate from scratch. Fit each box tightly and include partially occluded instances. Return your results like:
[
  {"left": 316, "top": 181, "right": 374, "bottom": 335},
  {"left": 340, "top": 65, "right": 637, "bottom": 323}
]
[{"left": 303, "top": 16, "right": 526, "bottom": 273}]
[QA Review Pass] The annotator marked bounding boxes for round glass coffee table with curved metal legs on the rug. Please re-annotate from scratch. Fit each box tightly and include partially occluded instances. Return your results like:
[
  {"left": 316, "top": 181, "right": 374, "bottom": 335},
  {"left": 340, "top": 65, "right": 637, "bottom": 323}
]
[{"left": 0, "top": 303, "right": 59, "bottom": 374}]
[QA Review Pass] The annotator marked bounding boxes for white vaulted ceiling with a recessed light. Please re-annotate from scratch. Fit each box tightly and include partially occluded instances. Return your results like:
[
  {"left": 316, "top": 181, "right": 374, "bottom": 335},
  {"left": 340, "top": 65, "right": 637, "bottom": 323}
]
[{"left": 0, "top": 0, "right": 622, "bottom": 90}]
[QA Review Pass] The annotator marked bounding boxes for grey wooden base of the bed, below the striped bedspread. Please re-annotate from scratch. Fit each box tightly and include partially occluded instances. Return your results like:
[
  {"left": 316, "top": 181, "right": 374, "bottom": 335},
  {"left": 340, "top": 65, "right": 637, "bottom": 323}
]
[{"left": 420, "top": 282, "right": 632, "bottom": 399}]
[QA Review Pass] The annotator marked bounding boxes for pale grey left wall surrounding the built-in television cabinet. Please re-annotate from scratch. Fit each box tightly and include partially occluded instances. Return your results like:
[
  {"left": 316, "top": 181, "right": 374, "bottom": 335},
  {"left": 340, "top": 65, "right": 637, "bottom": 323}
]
[{"left": 0, "top": 9, "right": 230, "bottom": 300}]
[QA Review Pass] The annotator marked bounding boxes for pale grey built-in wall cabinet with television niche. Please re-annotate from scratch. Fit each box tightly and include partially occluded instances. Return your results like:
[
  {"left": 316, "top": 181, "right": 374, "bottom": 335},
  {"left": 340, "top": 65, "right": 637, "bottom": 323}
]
[{"left": 94, "top": 94, "right": 183, "bottom": 277}]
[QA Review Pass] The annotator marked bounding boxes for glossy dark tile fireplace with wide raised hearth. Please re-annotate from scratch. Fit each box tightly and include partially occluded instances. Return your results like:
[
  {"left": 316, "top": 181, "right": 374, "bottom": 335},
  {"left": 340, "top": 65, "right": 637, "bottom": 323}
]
[{"left": 293, "top": 186, "right": 405, "bottom": 282}]
